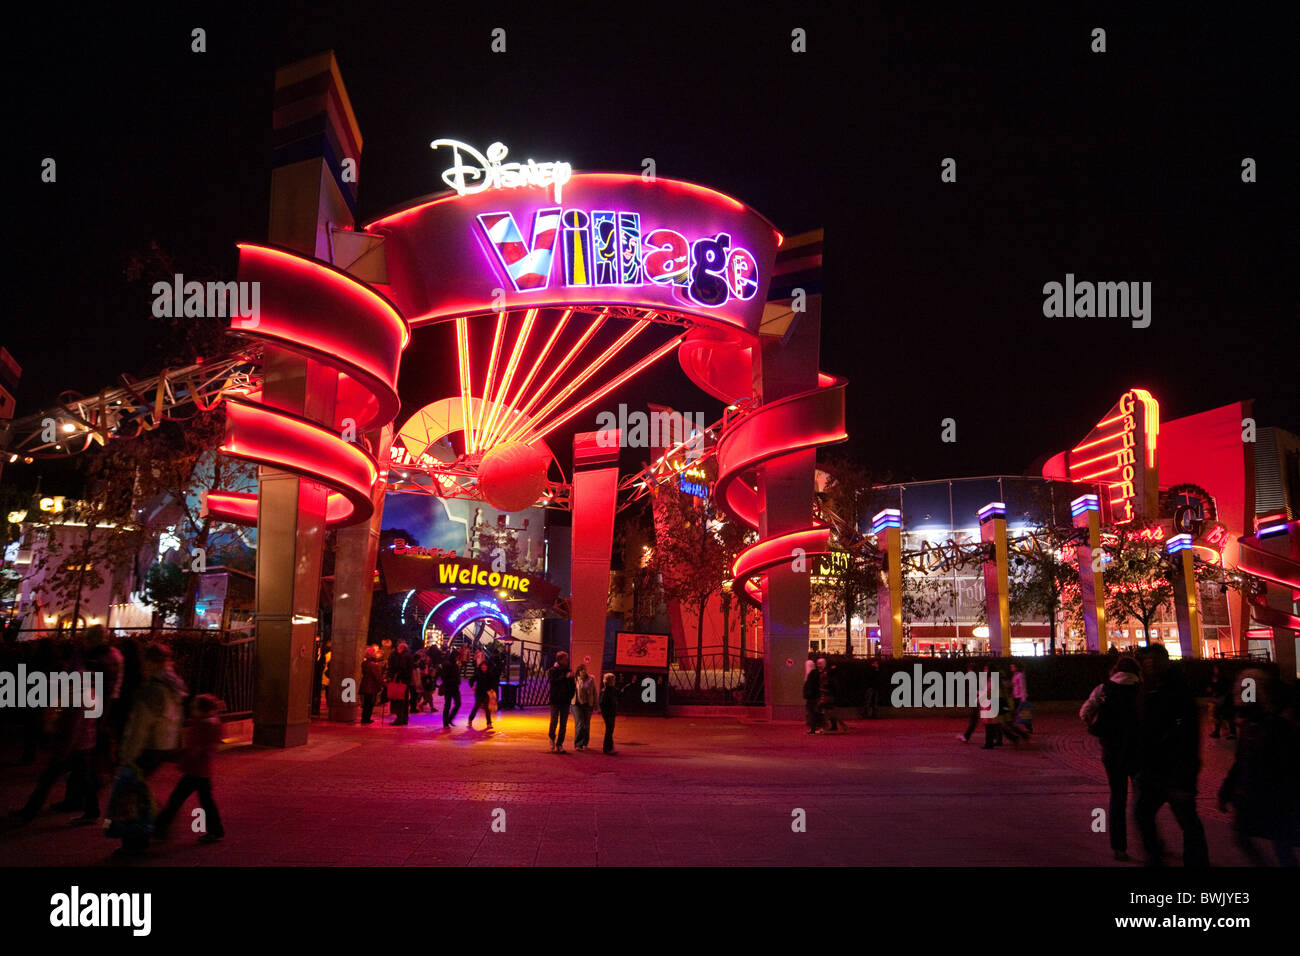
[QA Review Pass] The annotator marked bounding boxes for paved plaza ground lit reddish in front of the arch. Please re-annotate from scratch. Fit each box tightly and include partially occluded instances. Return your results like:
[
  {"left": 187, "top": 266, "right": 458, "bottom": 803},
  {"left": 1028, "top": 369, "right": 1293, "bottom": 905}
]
[{"left": 0, "top": 705, "right": 1268, "bottom": 866}]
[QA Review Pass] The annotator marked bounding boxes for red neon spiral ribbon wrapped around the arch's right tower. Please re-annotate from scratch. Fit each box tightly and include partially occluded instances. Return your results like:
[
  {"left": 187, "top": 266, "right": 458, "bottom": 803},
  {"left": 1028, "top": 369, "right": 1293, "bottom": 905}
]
[{"left": 679, "top": 333, "right": 849, "bottom": 605}]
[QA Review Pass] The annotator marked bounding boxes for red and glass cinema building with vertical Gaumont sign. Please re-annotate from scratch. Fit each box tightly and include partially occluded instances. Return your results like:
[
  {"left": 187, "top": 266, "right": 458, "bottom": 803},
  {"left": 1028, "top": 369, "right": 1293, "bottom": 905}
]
[{"left": 810, "top": 389, "right": 1300, "bottom": 663}]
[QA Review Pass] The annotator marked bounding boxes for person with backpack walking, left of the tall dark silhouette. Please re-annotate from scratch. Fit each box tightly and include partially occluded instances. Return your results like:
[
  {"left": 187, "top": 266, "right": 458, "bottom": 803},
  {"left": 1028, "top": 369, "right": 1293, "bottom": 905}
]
[{"left": 1079, "top": 657, "right": 1141, "bottom": 861}]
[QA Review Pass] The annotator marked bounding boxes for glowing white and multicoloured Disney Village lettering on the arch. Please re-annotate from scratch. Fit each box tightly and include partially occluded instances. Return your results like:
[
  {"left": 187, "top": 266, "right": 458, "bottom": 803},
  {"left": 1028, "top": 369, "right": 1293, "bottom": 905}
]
[{"left": 433, "top": 139, "right": 758, "bottom": 308}]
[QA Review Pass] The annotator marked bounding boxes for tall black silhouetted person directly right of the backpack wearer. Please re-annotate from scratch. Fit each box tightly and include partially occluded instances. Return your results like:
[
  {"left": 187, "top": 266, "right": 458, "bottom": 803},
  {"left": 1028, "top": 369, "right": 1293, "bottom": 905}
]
[{"left": 1134, "top": 644, "right": 1210, "bottom": 866}]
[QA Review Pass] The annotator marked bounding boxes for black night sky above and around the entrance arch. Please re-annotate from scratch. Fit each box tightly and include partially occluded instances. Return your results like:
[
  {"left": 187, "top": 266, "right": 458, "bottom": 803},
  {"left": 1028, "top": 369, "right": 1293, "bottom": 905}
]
[{"left": 12, "top": 4, "right": 1300, "bottom": 496}]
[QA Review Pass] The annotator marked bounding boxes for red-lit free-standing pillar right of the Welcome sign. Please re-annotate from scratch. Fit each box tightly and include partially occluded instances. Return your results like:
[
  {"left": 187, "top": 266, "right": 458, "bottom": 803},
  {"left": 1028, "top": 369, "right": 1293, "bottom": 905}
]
[{"left": 569, "top": 429, "right": 621, "bottom": 682}]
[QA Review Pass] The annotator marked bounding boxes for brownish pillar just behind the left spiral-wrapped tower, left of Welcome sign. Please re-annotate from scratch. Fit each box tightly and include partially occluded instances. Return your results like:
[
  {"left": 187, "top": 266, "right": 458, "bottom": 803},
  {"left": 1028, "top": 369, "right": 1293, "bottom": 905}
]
[{"left": 328, "top": 424, "right": 393, "bottom": 723}]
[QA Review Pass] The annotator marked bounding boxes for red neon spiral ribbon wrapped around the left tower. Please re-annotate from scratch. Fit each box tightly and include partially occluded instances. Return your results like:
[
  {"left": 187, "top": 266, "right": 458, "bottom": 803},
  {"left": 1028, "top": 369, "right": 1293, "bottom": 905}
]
[{"left": 207, "top": 243, "right": 411, "bottom": 525}]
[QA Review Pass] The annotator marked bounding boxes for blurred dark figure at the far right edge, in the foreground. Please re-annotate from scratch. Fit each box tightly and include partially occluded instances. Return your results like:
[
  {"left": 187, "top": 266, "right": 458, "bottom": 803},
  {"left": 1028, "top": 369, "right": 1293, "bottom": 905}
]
[{"left": 1218, "top": 669, "right": 1300, "bottom": 866}]
